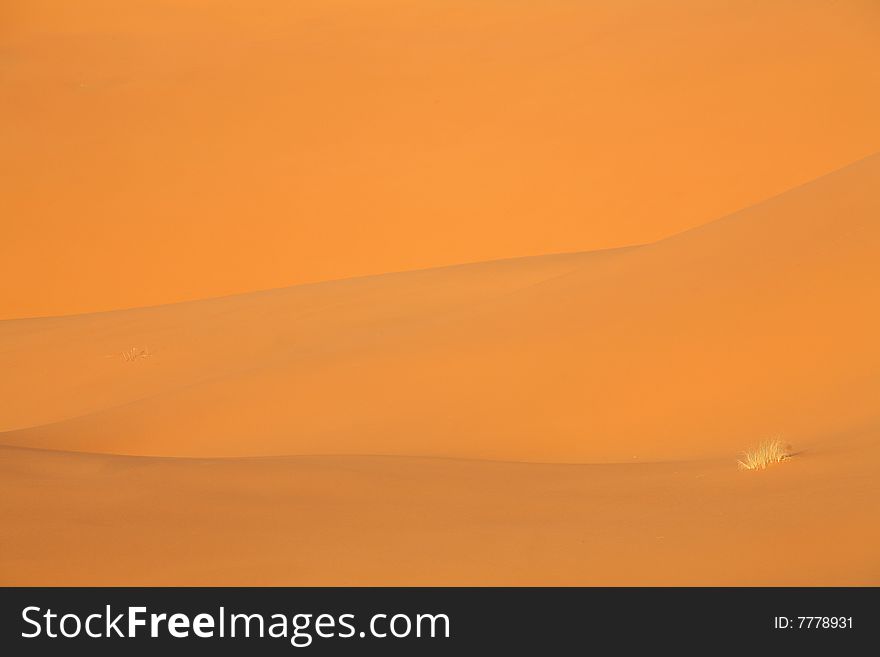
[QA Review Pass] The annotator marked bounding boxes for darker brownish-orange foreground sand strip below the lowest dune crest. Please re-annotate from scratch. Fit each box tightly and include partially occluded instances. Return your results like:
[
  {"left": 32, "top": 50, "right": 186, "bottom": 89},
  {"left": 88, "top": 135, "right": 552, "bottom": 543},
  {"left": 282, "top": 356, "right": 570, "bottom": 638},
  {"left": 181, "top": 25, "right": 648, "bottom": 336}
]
[{"left": 0, "top": 428, "right": 880, "bottom": 586}]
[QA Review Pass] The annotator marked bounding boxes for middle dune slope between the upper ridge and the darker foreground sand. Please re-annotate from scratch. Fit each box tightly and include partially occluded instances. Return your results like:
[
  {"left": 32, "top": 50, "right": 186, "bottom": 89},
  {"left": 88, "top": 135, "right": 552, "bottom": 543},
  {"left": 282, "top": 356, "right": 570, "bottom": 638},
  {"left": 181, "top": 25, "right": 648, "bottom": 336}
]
[{"left": 0, "top": 156, "right": 880, "bottom": 463}]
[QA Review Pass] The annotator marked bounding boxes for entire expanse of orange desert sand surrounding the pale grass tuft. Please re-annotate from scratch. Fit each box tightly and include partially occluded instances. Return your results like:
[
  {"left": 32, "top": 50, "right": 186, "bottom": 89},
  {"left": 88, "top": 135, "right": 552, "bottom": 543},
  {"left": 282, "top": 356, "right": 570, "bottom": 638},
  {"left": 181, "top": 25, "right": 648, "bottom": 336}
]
[{"left": 0, "top": 0, "right": 880, "bottom": 585}]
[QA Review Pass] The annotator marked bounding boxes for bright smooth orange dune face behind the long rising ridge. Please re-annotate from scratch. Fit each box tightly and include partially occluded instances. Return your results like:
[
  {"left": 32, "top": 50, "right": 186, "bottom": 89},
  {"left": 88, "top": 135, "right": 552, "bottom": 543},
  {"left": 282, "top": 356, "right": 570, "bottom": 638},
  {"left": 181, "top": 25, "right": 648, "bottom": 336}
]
[{"left": 0, "top": 0, "right": 880, "bottom": 318}]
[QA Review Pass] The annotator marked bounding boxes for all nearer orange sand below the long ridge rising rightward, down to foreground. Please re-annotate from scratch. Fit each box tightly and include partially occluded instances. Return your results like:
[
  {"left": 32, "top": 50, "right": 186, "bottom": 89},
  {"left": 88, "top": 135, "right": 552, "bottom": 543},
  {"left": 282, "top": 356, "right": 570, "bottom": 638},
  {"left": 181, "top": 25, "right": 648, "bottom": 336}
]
[{"left": 0, "top": 156, "right": 880, "bottom": 584}]
